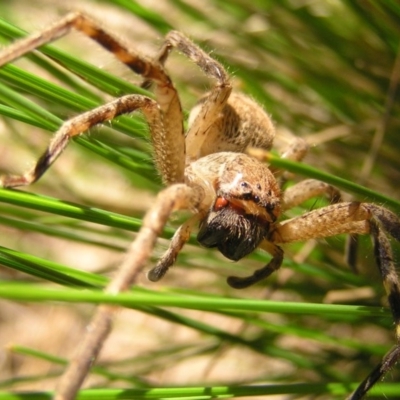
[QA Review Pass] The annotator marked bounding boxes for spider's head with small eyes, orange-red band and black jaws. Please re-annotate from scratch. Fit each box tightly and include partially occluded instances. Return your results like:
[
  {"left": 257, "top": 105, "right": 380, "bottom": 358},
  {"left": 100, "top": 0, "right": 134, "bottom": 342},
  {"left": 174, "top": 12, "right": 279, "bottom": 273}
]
[{"left": 197, "top": 154, "right": 280, "bottom": 261}]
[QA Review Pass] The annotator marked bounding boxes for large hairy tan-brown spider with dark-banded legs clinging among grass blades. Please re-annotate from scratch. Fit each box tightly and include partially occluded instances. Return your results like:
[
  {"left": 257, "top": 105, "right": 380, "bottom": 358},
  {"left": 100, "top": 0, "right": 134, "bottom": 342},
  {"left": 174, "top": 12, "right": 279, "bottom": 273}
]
[{"left": 0, "top": 13, "right": 400, "bottom": 400}]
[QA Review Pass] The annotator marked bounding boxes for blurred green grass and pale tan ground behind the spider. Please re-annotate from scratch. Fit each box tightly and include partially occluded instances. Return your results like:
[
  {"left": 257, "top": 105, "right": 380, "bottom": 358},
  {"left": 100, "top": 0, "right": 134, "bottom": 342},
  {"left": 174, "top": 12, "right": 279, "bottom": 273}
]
[{"left": 0, "top": 0, "right": 400, "bottom": 399}]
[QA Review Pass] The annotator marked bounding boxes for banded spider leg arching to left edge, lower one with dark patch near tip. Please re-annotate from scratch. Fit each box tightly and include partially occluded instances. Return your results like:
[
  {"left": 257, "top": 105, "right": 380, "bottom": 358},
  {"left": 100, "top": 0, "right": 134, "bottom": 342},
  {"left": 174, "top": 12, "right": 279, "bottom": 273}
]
[{"left": 0, "top": 95, "right": 164, "bottom": 187}]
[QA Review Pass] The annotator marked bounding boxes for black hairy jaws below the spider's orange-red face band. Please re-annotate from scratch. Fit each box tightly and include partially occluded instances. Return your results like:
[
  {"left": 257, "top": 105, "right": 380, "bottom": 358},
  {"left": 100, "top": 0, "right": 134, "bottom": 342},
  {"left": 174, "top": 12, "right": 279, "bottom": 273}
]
[{"left": 197, "top": 207, "right": 269, "bottom": 261}]
